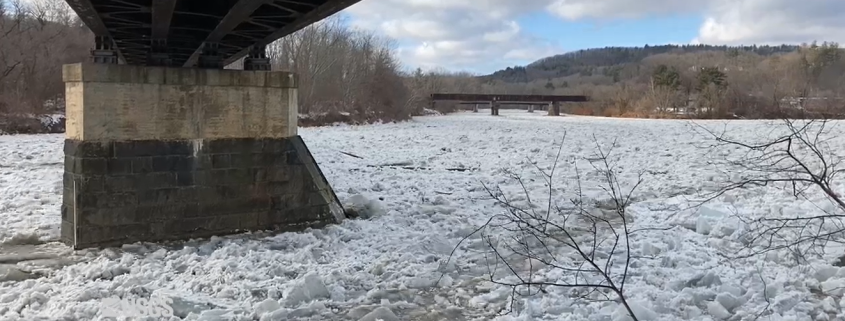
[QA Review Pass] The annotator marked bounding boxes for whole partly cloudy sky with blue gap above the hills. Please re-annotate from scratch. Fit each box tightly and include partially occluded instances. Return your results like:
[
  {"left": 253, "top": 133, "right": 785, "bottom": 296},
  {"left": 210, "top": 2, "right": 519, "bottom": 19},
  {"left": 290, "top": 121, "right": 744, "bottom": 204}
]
[{"left": 342, "top": 0, "right": 845, "bottom": 73}]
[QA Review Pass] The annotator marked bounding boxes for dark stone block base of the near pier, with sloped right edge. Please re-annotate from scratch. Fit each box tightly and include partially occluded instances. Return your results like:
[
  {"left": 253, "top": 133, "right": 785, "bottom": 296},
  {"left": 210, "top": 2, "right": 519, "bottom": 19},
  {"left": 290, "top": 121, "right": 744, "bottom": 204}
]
[{"left": 62, "top": 136, "right": 343, "bottom": 248}]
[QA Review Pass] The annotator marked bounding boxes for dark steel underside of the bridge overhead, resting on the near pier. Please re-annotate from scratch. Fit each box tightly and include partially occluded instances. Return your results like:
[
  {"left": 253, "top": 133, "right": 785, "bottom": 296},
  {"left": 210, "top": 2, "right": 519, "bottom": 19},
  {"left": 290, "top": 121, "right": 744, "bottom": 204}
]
[{"left": 67, "top": 0, "right": 360, "bottom": 70}]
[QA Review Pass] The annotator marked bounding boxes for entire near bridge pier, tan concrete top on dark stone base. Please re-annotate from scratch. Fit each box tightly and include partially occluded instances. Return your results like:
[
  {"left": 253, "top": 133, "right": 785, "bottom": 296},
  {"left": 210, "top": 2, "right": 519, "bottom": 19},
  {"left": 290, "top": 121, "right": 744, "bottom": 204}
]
[{"left": 61, "top": 64, "right": 344, "bottom": 249}]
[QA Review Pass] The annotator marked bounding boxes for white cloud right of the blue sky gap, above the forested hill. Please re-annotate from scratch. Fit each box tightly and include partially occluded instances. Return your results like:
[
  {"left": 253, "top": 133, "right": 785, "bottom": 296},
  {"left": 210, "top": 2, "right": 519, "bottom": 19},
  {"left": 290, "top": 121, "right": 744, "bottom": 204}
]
[{"left": 547, "top": 0, "right": 845, "bottom": 44}]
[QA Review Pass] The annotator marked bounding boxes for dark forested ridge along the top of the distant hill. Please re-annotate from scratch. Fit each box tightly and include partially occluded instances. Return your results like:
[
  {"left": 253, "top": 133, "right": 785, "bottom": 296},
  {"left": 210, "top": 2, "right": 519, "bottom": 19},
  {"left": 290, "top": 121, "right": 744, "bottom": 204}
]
[{"left": 482, "top": 45, "right": 798, "bottom": 83}]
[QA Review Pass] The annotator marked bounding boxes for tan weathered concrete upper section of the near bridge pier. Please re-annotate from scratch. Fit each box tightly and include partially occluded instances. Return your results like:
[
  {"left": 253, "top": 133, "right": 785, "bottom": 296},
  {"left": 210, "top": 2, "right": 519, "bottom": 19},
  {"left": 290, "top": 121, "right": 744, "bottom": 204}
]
[{"left": 63, "top": 64, "right": 297, "bottom": 141}]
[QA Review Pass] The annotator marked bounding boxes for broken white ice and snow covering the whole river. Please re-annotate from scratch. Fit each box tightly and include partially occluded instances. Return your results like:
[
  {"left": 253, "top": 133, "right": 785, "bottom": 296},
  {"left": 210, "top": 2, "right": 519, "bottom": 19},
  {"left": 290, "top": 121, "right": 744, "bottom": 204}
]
[{"left": 0, "top": 110, "right": 845, "bottom": 321}]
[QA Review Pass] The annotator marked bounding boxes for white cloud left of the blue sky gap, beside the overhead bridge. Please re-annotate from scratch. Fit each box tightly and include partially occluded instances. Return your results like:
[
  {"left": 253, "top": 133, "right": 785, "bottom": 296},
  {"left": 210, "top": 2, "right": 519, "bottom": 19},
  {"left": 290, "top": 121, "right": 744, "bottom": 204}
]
[{"left": 346, "top": 0, "right": 563, "bottom": 73}]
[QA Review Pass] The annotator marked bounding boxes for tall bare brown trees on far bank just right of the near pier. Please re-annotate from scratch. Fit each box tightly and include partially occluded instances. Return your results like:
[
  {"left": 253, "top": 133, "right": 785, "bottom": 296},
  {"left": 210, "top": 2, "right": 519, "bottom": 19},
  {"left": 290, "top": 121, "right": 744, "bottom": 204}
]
[{"left": 268, "top": 18, "right": 411, "bottom": 121}]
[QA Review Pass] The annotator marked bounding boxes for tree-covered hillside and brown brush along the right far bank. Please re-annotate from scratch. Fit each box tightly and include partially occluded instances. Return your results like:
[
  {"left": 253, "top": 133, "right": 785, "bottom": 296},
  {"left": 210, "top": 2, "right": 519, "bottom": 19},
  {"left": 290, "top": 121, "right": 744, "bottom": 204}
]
[{"left": 468, "top": 43, "right": 845, "bottom": 119}]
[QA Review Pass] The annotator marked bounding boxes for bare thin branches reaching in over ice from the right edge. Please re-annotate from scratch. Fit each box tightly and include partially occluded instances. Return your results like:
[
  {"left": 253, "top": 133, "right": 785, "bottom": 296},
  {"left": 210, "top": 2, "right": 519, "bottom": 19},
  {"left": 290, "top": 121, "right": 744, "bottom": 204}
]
[{"left": 699, "top": 119, "right": 845, "bottom": 262}]
